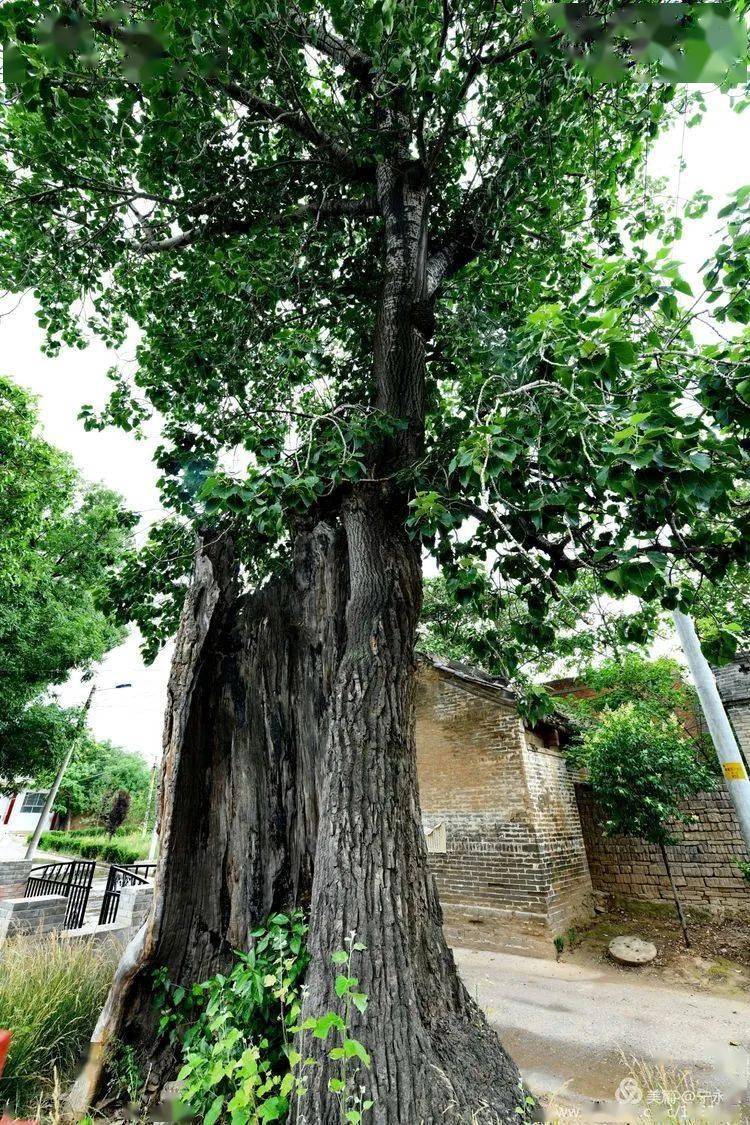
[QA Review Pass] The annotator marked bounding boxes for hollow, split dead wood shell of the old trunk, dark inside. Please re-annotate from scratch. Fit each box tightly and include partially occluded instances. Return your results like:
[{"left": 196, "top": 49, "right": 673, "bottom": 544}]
[{"left": 70, "top": 522, "right": 346, "bottom": 1112}]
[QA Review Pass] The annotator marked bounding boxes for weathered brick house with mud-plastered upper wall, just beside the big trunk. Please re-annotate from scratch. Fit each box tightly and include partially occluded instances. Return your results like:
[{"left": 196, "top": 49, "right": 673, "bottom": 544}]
[{"left": 416, "top": 659, "right": 591, "bottom": 933}]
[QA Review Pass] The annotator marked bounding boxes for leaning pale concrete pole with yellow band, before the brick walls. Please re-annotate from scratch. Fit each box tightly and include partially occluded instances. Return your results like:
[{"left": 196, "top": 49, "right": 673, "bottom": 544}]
[{"left": 674, "top": 610, "right": 750, "bottom": 853}]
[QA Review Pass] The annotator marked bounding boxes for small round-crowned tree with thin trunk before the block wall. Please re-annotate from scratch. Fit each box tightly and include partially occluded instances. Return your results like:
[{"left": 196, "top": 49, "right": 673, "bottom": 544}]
[{"left": 573, "top": 700, "right": 714, "bottom": 945}]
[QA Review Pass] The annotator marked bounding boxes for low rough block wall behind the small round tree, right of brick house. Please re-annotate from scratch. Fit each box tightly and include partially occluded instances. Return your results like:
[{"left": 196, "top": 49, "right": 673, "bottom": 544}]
[{"left": 576, "top": 783, "right": 750, "bottom": 915}]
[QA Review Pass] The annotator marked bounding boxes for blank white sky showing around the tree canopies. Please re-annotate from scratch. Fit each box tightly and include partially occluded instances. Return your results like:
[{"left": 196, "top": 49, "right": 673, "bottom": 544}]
[{"left": 0, "top": 91, "right": 750, "bottom": 761}]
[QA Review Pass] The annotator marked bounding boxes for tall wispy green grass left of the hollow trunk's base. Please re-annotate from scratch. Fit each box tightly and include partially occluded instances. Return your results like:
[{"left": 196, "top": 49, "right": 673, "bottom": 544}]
[{"left": 0, "top": 934, "right": 118, "bottom": 1114}]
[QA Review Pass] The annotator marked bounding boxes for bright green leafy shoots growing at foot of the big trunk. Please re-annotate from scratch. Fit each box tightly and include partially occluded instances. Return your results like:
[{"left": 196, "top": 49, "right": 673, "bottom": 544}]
[{"left": 156, "top": 911, "right": 372, "bottom": 1125}]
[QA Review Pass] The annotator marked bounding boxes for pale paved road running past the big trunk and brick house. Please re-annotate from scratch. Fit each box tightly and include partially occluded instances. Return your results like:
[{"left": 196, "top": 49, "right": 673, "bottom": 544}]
[{"left": 454, "top": 950, "right": 750, "bottom": 1119}]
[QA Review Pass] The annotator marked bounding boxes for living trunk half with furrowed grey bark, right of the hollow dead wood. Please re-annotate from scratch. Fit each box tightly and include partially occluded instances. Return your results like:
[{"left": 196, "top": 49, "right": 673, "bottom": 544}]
[{"left": 296, "top": 489, "right": 523, "bottom": 1125}]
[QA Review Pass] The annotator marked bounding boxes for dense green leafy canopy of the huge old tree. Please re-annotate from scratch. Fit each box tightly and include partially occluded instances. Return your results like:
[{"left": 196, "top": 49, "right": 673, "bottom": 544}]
[{"left": 0, "top": 0, "right": 750, "bottom": 647}]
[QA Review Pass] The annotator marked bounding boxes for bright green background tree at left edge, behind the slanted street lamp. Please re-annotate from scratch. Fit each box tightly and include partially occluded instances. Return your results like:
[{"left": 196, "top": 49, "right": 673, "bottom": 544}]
[{"left": 0, "top": 377, "right": 137, "bottom": 790}]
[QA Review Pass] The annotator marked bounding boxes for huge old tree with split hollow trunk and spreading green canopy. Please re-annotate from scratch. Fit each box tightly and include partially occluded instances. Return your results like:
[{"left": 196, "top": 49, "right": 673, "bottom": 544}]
[{"left": 0, "top": 0, "right": 750, "bottom": 1125}]
